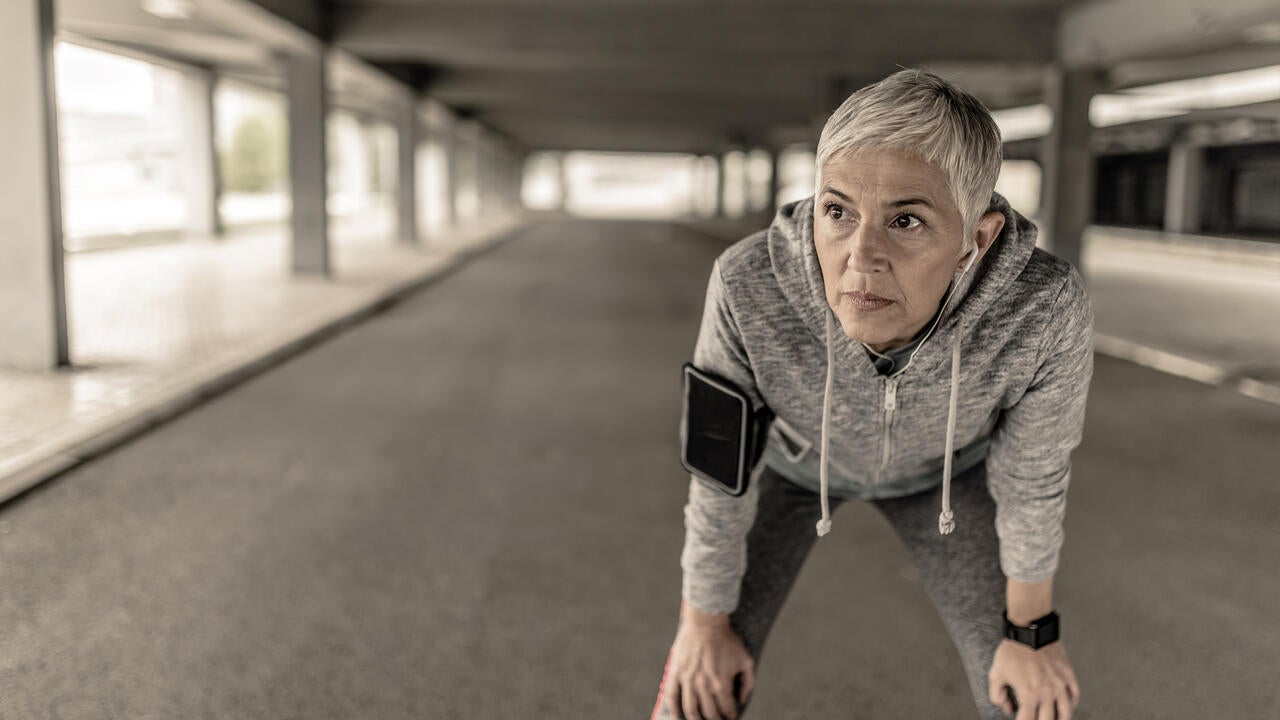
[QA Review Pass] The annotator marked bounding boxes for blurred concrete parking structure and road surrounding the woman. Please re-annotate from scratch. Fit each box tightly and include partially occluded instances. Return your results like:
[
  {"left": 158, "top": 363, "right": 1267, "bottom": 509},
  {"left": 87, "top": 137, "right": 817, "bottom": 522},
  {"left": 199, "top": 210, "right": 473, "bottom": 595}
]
[{"left": 0, "top": 0, "right": 1280, "bottom": 717}]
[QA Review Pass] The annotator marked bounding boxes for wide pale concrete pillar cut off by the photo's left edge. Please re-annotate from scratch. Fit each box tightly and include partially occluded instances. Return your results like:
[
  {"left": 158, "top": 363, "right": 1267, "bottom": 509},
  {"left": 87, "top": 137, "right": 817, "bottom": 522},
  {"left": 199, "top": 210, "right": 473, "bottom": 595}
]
[{"left": 0, "top": 0, "right": 70, "bottom": 370}]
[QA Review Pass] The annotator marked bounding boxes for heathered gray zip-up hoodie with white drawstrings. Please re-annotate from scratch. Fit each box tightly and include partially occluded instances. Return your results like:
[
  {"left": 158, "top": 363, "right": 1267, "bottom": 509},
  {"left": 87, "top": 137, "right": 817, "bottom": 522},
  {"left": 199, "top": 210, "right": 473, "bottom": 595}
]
[{"left": 681, "top": 193, "right": 1093, "bottom": 614}]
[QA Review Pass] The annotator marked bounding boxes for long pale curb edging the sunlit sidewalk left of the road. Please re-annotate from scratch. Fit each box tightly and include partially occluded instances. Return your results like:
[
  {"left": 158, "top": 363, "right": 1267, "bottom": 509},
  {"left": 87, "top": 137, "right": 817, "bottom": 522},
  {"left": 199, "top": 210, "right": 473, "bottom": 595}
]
[{"left": 0, "top": 218, "right": 530, "bottom": 505}]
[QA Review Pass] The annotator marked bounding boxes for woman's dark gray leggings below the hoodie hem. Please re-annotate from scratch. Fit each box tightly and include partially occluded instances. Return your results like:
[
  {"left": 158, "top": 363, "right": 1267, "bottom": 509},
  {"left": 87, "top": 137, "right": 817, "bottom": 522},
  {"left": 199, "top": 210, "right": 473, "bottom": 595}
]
[{"left": 652, "top": 462, "right": 1009, "bottom": 720}]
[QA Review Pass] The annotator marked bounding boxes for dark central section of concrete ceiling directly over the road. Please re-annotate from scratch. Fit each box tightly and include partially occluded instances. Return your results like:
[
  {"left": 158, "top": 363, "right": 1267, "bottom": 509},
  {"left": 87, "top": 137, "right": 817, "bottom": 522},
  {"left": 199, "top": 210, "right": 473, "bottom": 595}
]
[{"left": 332, "top": 0, "right": 1070, "bottom": 151}]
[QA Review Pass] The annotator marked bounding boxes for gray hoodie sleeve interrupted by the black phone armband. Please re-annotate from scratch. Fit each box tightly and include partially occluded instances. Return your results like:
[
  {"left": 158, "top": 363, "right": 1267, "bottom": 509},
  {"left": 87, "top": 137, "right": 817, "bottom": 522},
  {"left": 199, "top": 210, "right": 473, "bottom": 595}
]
[{"left": 680, "top": 254, "right": 764, "bottom": 615}]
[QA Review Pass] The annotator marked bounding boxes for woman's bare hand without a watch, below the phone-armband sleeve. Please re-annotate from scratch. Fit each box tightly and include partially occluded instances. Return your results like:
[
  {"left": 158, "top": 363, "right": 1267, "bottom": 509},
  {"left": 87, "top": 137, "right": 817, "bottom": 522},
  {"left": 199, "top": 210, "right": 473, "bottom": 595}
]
[{"left": 663, "top": 605, "right": 755, "bottom": 720}]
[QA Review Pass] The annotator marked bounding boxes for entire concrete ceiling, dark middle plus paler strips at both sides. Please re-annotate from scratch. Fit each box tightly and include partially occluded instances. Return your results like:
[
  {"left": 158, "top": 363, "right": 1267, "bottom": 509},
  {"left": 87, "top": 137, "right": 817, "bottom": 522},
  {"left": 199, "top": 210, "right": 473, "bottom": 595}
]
[{"left": 55, "top": 0, "right": 1280, "bottom": 152}]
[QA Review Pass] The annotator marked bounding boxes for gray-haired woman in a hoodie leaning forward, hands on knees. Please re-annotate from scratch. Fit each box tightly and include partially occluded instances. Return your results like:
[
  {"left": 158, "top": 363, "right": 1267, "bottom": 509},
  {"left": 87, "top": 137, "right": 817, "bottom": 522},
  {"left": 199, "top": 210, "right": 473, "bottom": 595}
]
[{"left": 653, "top": 70, "right": 1093, "bottom": 720}]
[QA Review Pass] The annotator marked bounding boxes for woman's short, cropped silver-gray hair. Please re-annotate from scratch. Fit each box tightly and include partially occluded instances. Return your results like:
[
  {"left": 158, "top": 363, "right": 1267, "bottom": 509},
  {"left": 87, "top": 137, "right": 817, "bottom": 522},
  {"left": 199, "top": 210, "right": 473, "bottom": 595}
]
[{"left": 814, "top": 69, "right": 1004, "bottom": 250}]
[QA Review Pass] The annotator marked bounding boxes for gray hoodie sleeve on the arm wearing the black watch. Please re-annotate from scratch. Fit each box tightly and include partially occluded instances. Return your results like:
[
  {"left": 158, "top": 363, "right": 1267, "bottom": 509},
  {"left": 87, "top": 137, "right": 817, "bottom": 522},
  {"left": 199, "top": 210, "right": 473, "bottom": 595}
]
[{"left": 987, "top": 268, "right": 1093, "bottom": 583}]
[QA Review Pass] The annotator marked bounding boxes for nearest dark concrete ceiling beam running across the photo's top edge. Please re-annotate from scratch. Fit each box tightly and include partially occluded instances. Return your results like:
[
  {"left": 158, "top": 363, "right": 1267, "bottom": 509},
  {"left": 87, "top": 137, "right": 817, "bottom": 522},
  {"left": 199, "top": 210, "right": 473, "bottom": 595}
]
[{"left": 333, "top": 4, "right": 1055, "bottom": 65}]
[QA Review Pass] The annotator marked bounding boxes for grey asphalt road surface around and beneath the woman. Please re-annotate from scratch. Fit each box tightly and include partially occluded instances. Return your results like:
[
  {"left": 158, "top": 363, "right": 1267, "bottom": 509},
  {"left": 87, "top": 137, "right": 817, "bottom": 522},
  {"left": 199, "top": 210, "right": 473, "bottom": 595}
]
[{"left": 0, "top": 222, "right": 1280, "bottom": 720}]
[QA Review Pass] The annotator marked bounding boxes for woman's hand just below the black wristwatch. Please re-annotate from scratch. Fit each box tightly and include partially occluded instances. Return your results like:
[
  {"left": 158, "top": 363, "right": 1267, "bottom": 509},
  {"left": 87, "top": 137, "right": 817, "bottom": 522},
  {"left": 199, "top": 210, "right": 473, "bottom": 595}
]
[{"left": 988, "top": 639, "right": 1080, "bottom": 720}]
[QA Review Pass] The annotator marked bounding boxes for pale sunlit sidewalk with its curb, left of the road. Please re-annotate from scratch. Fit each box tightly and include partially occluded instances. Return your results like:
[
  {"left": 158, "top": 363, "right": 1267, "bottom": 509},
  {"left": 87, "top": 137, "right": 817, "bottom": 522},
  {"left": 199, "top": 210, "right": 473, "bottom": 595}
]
[{"left": 0, "top": 217, "right": 522, "bottom": 501}]
